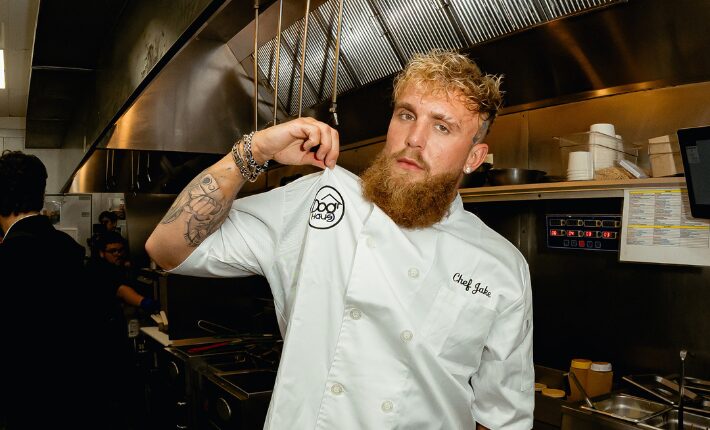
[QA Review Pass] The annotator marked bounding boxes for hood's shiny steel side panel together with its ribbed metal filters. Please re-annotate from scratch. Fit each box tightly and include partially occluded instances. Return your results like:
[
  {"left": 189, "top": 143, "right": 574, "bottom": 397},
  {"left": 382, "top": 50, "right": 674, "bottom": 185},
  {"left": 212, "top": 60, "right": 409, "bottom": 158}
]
[{"left": 98, "top": 0, "right": 620, "bottom": 153}]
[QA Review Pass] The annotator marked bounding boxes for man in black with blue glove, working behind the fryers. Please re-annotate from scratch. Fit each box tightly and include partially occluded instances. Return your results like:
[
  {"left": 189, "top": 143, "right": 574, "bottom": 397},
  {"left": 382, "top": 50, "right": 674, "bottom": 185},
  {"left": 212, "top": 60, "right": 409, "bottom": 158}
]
[{"left": 87, "top": 231, "right": 160, "bottom": 428}]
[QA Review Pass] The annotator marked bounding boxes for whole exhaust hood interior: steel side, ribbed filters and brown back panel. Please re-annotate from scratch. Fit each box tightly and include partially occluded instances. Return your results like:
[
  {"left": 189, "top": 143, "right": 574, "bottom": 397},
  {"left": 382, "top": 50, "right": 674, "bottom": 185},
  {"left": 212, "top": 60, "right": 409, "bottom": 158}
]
[{"left": 64, "top": 0, "right": 710, "bottom": 191}]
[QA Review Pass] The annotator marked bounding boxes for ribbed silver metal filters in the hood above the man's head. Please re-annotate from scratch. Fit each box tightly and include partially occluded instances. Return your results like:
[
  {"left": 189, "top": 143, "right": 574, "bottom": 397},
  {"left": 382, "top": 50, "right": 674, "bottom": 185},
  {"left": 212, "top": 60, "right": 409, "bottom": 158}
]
[{"left": 258, "top": 0, "right": 626, "bottom": 115}]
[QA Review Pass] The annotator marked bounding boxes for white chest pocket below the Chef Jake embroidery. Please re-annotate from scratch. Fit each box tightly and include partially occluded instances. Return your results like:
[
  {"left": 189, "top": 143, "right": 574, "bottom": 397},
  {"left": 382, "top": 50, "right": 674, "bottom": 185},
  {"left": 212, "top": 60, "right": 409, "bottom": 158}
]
[{"left": 422, "top": 285, "right": 495, "bottom": 377}]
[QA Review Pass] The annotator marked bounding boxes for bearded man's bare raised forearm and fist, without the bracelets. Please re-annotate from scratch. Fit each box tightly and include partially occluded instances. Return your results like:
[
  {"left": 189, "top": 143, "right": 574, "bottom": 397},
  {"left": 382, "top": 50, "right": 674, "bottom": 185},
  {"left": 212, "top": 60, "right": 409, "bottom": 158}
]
[{"left": 145, "top": 118, "right": 339, "bottom": 269}]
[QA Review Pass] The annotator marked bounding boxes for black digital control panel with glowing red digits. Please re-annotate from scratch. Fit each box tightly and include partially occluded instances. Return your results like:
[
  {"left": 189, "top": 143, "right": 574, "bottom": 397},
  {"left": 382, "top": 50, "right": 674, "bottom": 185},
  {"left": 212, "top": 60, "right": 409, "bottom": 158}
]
[{"left": 545, "top": 214, "right": 621, "bottom": 251}]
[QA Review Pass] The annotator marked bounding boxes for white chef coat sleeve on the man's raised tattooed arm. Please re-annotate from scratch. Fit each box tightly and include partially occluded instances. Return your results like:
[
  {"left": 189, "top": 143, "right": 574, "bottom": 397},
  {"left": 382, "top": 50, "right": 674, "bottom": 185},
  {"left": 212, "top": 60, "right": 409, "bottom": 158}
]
[{"left": 171, "top": 187, "right": 285, "bottom": 277}]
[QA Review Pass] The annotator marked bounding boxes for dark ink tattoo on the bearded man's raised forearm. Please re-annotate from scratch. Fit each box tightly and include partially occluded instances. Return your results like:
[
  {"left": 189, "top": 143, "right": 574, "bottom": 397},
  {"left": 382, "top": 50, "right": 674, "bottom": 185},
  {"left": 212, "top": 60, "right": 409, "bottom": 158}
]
[{"left": 160, "top": 173, "right": 230, "bottom": 247}]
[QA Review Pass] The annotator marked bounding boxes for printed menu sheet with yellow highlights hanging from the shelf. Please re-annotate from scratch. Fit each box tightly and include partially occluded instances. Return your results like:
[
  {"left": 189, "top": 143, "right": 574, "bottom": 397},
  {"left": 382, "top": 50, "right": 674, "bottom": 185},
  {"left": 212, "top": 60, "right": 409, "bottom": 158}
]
[{"left": 619, "top": 188, "right": 710, "bottom": 266}]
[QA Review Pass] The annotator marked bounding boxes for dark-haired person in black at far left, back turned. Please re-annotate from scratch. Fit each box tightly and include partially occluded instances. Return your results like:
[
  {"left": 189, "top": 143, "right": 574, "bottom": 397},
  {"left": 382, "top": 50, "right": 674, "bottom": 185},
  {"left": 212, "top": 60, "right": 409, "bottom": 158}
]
[{"left": 0, "top": 151, "right": 105, "bottom": 430}]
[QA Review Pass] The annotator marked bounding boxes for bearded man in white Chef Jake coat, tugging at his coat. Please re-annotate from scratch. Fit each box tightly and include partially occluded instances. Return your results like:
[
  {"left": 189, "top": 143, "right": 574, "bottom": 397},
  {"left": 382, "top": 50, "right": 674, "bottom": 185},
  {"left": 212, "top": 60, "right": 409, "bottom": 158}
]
[{"left": 146, "top": 50, "right": 534, "bottom": 429}]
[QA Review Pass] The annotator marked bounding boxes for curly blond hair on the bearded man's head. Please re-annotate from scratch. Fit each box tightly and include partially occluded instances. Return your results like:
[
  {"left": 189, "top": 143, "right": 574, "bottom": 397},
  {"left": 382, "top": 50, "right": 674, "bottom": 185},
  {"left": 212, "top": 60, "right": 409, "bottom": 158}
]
[{"left": 393, "top": 49, "right": 503, "bottom": 129}]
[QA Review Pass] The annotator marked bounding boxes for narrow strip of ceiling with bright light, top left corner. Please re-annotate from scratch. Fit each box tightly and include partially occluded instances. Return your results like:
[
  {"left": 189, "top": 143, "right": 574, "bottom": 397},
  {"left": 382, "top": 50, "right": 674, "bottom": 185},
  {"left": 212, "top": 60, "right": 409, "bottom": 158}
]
[{"left": 0, "top": 0, "right": 39, "bottom": 117}]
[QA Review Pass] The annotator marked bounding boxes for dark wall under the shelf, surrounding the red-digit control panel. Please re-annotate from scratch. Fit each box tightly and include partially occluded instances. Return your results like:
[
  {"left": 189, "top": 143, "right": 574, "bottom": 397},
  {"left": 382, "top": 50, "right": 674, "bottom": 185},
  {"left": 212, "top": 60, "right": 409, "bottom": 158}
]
[{"left": 466, "top": 198, "right": 710, "bottom": 380}]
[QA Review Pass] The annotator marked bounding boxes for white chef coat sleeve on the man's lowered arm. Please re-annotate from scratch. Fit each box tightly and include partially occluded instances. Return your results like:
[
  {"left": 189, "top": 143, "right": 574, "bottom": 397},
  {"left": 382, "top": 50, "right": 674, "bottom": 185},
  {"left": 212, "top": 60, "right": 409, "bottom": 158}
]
[{"left": 471, "top": 263, "right": 535, "bottom": 430}]
